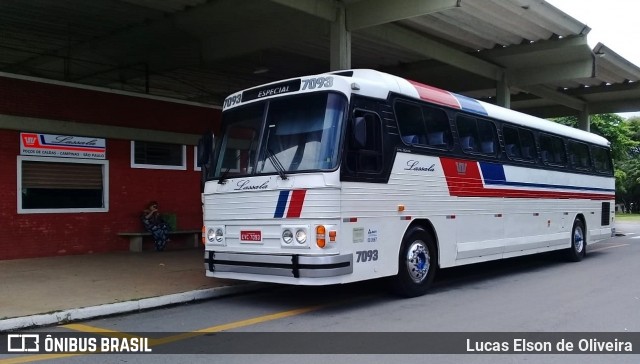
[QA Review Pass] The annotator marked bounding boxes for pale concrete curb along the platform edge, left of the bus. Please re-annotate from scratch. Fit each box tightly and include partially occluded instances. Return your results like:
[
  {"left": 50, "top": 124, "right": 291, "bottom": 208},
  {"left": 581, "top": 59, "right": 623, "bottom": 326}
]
[{"left": 0, "top": 283, "right": 264, "bottom": 332}]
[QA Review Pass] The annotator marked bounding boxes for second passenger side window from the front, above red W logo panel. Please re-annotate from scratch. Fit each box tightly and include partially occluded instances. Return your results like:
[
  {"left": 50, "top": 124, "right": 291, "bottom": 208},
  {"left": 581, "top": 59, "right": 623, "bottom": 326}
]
[{"left": 456, "top": 115, "right": 498, "bottom": 155}]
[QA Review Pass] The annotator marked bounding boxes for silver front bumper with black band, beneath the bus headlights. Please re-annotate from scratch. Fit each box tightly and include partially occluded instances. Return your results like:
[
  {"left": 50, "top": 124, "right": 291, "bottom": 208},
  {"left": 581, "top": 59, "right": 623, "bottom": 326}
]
[{"left": 204, "top": 251, "right": 353, "bottom": 278}]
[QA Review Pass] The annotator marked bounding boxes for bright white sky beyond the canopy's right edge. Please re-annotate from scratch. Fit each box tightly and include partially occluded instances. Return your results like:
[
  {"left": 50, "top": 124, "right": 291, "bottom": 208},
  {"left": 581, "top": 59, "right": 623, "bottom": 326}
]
[{"left": 546, "top": 0, "right": 640, "bottom": 117}]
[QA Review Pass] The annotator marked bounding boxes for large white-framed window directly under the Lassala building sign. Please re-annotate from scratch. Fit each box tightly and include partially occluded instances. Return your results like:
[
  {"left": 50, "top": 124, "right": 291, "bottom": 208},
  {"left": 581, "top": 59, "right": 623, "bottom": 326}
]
[{"left": 18, "top": 157, "right": 108, "bottom": 213}]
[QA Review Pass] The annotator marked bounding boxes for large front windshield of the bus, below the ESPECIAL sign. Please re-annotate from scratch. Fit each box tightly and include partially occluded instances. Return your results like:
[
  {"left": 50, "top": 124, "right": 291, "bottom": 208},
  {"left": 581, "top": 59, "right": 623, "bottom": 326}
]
[{"left": 213, "top": 93, "right": 347, "bottom": 179}]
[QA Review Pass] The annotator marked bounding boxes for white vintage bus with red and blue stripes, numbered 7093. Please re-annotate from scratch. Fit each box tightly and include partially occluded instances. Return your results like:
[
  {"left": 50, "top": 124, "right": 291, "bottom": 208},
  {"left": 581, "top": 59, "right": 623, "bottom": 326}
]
[{"left": 199, "top": 69, "right": 615, "bottom": 297}]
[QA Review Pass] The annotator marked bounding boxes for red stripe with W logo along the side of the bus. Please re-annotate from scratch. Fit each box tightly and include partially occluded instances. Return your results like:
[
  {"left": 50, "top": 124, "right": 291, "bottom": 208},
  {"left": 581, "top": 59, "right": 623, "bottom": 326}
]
[{"left": 440, "top": 158, "right": 614, "bottom": 200}]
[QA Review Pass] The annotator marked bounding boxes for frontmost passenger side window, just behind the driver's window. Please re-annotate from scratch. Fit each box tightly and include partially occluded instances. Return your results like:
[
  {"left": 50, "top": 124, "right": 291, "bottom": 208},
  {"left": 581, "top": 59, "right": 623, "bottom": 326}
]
[{"left": 395, "top": 102, "right": 451, "bottom": 149}]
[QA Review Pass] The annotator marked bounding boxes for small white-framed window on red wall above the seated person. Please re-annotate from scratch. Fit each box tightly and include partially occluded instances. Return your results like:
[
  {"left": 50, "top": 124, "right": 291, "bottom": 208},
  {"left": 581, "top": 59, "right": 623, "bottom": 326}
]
[{"left": 131, "top": 141, "right": 187, "bottom": 170}]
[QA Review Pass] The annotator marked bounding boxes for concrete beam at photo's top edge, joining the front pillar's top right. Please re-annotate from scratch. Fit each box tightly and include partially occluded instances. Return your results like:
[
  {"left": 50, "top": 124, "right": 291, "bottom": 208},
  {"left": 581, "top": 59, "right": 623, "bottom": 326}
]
[{"left": 344, "top": 0, "right": 461, "bottom": 31}]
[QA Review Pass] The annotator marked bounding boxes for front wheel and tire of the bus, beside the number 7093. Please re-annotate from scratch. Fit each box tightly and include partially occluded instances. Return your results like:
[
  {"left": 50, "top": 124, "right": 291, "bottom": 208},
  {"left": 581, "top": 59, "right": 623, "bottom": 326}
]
[{"left": 392, "top": 227, "right": 438, "bottom": 297}]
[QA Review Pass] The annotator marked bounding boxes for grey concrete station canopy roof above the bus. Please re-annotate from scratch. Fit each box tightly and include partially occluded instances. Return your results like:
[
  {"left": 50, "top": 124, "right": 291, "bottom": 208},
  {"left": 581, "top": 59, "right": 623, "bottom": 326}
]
[{"left": 0, "top": 0, "right": 640, "bottom": 117}]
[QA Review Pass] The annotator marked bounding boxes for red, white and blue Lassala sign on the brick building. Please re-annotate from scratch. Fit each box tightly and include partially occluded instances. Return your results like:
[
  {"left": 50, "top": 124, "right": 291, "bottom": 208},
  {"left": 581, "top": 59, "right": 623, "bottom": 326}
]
[{"left": 20, "top": 133, "right": 107, "bottom": 159}]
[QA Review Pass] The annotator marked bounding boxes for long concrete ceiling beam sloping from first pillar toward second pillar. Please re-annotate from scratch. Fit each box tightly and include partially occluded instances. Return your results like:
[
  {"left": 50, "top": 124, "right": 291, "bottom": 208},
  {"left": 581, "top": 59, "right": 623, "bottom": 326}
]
[{"left": 361, "top": 24, "right": 504, "bottom": 80}]
